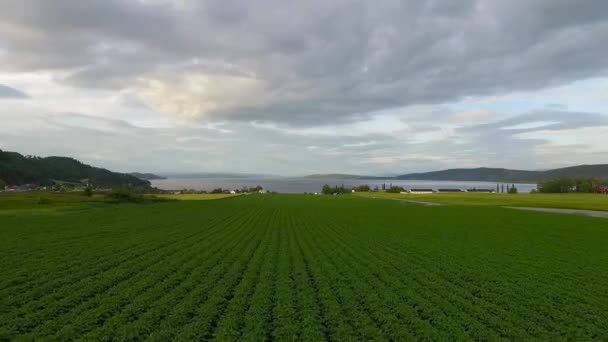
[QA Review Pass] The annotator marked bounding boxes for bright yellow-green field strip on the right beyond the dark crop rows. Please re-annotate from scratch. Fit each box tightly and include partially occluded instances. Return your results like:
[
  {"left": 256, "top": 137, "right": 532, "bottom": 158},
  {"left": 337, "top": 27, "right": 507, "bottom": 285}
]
[{"left": 355, "top": 192, "right": 608, "bottom": 211}]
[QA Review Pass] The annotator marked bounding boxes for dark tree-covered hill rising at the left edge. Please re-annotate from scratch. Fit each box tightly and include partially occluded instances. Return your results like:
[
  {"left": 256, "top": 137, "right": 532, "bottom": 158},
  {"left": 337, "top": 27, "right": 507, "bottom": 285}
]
[{"left": 0, "top": 150, "right": 150, "bottom": 188}]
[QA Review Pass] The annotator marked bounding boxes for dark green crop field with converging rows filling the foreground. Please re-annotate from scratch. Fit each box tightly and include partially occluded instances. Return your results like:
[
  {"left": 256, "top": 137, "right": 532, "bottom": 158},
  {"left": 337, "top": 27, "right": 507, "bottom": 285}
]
[{"left": 0, "top": 195, "right": 608, "bottom": 341}]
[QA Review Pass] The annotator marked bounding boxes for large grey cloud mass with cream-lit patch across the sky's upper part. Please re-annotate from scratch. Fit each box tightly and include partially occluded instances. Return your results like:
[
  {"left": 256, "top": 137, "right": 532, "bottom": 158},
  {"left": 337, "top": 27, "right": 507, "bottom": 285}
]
[{"left": 0, "top": 0, "right": 608, "bottom": 126}]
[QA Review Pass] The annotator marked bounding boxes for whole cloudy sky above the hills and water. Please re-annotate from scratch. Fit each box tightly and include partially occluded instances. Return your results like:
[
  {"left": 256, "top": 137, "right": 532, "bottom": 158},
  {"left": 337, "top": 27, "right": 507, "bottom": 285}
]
[{"left": 0, "top": 0, "right": 608, "bottom": 175}]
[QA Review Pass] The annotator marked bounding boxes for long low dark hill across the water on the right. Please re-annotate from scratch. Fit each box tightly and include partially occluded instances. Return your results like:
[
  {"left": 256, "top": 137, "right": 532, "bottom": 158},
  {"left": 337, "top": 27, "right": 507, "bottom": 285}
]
[{"left": 396, "top": 164, "right": 608, "bottom": 183}]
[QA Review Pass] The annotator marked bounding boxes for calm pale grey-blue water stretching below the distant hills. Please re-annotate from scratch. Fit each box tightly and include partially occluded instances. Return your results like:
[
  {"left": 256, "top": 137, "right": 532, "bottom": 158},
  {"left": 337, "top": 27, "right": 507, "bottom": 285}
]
[{"left": 152, "top": 177, "right": 536, "bottom": 193}]
